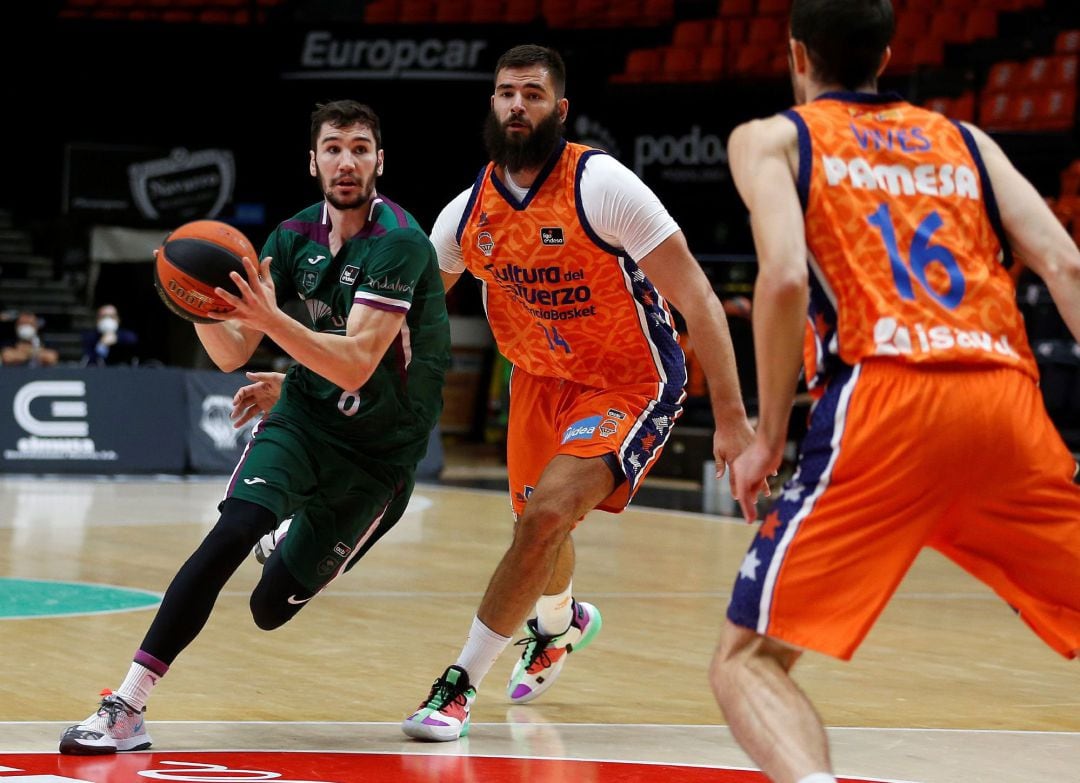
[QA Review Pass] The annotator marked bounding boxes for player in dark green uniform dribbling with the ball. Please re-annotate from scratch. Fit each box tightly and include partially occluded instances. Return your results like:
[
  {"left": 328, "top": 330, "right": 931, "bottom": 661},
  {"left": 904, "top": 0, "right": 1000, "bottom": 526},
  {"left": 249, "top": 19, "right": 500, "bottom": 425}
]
[{"left": 59, "top": 100, "right": 449, "bottom": 755}]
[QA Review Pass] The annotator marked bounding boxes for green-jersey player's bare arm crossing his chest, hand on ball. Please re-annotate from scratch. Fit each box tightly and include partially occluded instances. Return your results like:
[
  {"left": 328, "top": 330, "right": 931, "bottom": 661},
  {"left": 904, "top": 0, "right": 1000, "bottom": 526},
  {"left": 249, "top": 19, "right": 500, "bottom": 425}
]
[{"left": 215, "top": 258, "right": 405, "bottom": 389}]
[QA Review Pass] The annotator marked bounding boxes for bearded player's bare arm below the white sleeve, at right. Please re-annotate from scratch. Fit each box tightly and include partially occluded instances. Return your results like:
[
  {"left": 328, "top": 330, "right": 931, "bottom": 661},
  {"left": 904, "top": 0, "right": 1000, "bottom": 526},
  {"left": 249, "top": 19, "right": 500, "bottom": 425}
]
[{"left": 640, "top": 225, "right": 754, "bottom": 476}]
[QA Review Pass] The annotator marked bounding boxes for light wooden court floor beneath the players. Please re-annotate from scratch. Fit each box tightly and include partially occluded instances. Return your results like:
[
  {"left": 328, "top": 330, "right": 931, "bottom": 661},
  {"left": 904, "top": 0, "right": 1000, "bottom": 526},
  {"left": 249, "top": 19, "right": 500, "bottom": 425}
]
[{"left": 0, "top": 477, "right": 1080, "bottom": 783}]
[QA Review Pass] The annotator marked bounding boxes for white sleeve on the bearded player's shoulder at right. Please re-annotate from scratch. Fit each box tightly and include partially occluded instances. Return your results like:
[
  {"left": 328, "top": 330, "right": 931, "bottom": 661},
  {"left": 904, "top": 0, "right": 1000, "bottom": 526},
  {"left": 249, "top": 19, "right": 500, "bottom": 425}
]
[{"left": 578, "top": 154, "right": 678, "bottom": 261}]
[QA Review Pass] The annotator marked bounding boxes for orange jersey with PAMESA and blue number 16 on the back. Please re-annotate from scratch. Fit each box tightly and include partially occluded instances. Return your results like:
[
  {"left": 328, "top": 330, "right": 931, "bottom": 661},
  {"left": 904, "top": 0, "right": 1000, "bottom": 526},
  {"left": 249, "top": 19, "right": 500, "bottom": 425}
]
[{"left": 785, "top": 93, "right": 1038, "bottom": 391}]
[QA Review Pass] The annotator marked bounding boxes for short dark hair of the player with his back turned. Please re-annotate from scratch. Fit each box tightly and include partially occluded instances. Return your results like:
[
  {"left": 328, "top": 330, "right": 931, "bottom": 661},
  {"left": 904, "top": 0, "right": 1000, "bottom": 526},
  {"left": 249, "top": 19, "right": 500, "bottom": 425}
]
[{"left": 791, "top": 0, "right": 896, "bottom": 90}]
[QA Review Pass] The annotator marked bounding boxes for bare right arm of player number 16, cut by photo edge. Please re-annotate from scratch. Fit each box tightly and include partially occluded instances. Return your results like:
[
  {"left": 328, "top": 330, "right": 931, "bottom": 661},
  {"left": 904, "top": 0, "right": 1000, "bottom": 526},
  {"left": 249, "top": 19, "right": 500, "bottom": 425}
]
[{"left": 966, "top": 124, "right": 1080, "bottom": 340}]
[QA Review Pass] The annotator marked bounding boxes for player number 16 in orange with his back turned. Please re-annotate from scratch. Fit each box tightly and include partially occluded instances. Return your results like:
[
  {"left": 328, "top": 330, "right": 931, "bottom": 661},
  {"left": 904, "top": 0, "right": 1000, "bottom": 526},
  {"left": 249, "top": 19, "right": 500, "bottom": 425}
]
[{"left": 711, "top": 0, "right": 1080, "bottom": 783}]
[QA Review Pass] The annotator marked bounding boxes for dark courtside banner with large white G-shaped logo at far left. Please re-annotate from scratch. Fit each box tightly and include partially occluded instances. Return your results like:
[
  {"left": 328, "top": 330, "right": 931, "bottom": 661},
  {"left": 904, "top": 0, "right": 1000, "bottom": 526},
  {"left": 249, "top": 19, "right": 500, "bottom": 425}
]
[{"left": 0, "top": 367, "right": 188, "bottom": 474}]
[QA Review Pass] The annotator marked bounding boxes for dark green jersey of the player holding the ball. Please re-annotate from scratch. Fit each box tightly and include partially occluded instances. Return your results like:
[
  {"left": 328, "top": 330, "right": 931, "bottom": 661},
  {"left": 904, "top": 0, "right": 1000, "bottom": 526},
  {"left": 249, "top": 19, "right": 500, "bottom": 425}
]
[{"left": 260, "top": 197, "right": 450, "bottom": 464}]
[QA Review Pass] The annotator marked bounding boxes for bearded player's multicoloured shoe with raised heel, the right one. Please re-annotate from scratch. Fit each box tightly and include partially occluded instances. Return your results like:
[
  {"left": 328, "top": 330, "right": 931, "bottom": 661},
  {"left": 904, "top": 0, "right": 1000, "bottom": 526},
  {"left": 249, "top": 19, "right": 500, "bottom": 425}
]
[{"left": 507, "top": 600, "right": 604, "bottom": 704}]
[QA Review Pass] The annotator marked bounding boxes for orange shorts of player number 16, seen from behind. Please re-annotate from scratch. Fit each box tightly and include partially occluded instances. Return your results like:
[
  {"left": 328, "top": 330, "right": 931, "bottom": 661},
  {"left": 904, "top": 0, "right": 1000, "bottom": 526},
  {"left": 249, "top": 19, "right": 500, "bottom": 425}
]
[{"left": 728, "top": 361, "right": 1080, "bottom": 659}]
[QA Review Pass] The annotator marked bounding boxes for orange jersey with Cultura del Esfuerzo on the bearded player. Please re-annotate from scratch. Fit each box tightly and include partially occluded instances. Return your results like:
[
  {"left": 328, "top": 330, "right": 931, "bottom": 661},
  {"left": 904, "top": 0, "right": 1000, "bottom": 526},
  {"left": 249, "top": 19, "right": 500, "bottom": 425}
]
[{"left": 458, "top": 141, "right": 686, "bottom": 397}]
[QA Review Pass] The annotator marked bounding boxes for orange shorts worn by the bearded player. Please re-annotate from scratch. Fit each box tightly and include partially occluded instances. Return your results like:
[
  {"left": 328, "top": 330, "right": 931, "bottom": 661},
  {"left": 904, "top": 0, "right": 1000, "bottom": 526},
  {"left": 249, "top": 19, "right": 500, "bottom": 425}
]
[{"left": 507, "top": 367, "right": 685, "bottom": 516}]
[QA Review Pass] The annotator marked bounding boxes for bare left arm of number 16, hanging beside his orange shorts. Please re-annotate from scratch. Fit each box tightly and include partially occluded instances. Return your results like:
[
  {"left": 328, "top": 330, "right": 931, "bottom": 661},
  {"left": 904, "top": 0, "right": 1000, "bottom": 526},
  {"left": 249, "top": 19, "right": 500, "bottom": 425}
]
[{"left": 728, "top": 117, "right": 809, "bottom": 521}]
